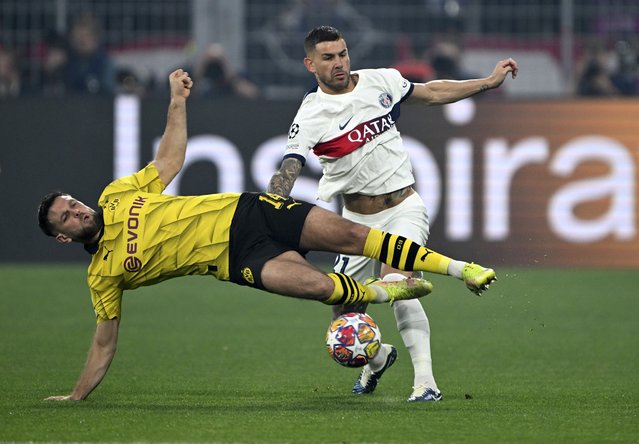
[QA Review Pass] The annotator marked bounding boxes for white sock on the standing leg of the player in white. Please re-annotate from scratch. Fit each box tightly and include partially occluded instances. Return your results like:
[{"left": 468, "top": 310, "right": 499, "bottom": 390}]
[{"left": 384, "top": 267, "right": 440, "bottom": 390}]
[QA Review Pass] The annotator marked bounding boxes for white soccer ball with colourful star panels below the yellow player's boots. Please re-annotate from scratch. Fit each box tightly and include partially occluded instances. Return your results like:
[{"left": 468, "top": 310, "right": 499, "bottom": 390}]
[{"left": 326, "top": 313, "right": 382, "bottom": 367}]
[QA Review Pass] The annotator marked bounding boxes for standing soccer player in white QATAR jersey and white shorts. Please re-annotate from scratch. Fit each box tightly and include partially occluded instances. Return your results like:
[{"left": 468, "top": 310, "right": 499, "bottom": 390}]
[{"left": 268, "top": 26, "right": 518, "bottom": 402}]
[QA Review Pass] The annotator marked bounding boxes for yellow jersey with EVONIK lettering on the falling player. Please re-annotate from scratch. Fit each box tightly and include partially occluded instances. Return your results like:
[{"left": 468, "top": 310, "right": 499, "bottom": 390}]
[{"left": 88, "top": 164, "right": 240, "bottom": 322}]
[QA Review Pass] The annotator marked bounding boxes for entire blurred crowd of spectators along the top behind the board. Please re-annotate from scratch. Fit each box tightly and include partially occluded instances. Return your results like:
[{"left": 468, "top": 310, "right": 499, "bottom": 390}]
[{"left": 0, "top": 15, "right": 639, "bottom": 99}]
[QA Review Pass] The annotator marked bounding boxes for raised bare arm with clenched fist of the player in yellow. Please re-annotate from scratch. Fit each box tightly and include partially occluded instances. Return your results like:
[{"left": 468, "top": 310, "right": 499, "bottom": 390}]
[{"left": 152, "top": 69, "right": 193, "bottom": 186}]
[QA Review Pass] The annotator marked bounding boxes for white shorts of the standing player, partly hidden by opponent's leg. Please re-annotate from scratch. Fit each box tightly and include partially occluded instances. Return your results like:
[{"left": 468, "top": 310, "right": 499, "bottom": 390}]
[{"left": 334, "top": 193, "right": 430, "bottom": 282}]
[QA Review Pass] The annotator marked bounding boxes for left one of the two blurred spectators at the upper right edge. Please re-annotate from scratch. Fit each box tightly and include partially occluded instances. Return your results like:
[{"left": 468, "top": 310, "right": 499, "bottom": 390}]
[{"left": 576, "top": 41, "right": 617, "bottom": 96}]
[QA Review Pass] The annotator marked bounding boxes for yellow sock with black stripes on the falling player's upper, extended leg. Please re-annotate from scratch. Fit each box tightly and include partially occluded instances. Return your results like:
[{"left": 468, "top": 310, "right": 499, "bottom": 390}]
[{"left": 363, "top": 228, "right": 452, "bottom": 274}]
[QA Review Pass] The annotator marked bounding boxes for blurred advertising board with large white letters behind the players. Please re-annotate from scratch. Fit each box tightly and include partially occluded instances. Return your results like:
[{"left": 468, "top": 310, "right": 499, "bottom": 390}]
[{"left": 0, "top": 97, "right": 639, "bottom": 267}]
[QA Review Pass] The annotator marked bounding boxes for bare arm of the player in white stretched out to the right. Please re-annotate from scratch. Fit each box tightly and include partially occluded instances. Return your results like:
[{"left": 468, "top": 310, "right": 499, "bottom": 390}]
[{"left": 406, "top": 58, "right": 519, "bottom": 105}]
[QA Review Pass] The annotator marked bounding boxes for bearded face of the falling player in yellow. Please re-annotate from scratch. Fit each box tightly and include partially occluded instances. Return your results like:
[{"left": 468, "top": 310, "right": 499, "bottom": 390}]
[{"left": 49, "top": 195, "right": 103, "bottom": 243}]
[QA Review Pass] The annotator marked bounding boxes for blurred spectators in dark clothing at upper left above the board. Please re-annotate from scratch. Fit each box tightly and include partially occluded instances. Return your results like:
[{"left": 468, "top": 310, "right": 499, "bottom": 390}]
[{"left": 0, "top": 15, "right": 260, "bottom": 98}]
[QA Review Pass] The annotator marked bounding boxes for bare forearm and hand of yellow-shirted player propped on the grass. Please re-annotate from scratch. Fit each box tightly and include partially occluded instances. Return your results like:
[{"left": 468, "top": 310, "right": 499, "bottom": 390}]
[{"left": 46, "top": 319, "right": 119, "bottom": 401}]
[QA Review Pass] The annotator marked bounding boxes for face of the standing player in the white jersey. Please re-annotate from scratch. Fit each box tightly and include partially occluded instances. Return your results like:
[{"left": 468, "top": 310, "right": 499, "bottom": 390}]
[{"left": 304, "top": 39, "right": 354, "bottom": 94}]
